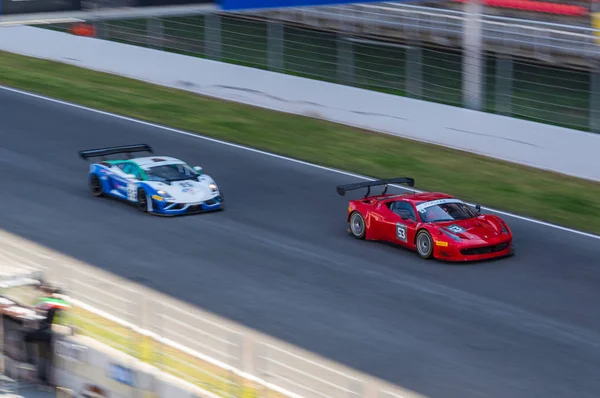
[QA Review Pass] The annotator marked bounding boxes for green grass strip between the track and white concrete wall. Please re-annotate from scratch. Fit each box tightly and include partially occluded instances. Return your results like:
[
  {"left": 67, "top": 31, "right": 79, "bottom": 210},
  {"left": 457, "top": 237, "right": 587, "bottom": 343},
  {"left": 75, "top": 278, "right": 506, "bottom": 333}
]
[{"left": 0, "top": 52, "right": 600, "bottom": 233}]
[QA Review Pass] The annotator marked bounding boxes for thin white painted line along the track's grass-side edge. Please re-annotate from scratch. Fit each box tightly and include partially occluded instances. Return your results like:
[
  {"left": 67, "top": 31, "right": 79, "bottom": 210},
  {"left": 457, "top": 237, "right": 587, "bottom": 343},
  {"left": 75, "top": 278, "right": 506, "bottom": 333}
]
[{"left": 0, "top": 85, "right": 600, "bottom": 240}]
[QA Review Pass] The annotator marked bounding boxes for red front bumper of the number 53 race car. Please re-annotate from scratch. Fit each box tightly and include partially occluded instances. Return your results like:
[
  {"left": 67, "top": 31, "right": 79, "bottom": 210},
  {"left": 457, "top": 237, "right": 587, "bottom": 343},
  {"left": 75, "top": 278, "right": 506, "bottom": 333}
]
[{"left": 434, "top": 238, "right": 514, "bottom": 262}]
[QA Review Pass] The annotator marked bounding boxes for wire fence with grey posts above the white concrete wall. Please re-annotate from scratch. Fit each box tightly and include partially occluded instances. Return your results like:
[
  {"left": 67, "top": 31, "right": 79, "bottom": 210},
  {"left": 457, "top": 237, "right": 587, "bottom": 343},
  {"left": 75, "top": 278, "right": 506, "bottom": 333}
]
[{"left": 42, "top": 6, "right": 600, "bottom": 131}]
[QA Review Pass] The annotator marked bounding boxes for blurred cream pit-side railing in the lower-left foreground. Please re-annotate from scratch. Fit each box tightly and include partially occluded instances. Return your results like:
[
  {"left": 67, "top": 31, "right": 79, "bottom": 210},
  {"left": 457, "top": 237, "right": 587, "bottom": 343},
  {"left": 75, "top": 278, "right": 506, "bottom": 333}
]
[{"left": 0, "top": 230, "right": 422, "bottom": 398}]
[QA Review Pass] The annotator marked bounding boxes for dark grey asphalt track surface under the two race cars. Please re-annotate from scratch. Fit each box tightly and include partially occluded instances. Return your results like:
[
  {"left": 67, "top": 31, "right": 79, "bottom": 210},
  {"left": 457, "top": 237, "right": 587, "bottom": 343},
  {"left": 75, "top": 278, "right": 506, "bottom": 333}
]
[{"left": 0, "top": 91, "right": 600, "bottom": 398}]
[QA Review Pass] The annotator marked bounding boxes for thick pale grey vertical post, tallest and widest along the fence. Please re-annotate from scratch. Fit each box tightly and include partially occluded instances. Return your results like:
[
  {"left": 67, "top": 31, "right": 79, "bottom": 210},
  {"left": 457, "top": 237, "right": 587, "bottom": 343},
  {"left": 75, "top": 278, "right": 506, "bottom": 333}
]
[{"left": 462, "top": 0, "right": 484, "bottom": 110}]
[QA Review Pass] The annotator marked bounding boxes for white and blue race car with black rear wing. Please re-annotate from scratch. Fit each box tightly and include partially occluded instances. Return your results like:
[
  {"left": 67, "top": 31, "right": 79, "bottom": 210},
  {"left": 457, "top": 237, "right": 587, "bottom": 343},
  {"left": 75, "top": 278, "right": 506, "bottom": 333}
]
[{"left": 79, "top": 144, "right": 225, "bottom": 215}]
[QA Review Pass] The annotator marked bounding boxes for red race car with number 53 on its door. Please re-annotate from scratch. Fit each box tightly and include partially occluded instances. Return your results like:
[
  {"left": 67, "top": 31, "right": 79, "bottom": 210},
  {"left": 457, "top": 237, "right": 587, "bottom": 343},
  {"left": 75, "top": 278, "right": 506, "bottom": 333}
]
[{"left": 337, "top": 177, "right": 513, "bottom": 261}]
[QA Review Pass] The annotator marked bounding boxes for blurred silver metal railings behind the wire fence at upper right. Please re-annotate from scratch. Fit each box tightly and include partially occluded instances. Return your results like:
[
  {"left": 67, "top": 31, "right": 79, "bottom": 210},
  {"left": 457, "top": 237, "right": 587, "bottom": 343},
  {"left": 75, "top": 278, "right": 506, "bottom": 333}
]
[{"left": 251, "top": 3, "right": 600, "bottom": 60}]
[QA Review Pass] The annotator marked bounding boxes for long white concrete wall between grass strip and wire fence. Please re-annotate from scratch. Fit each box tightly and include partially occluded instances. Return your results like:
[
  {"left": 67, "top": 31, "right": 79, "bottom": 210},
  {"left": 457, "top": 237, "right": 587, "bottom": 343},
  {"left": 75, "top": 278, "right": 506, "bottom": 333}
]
[{"left": 0, "top": 26, "right": 600, "bottom": 181}]
